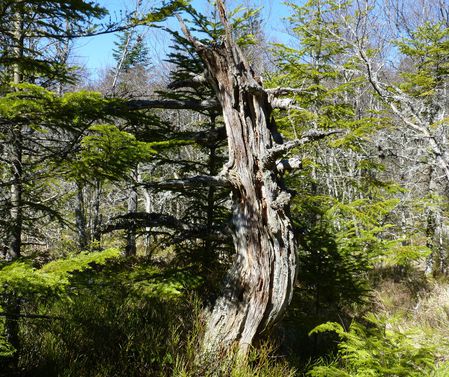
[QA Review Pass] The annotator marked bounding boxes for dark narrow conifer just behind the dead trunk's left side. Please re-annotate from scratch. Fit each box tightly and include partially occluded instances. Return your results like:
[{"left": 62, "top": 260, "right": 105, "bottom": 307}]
[{"left": 157, "top": 7, "right": 231, "bottom": 274}]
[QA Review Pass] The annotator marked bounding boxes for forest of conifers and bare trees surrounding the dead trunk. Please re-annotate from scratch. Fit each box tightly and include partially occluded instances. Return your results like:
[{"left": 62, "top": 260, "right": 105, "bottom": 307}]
[{"left": 0, "top": 0, "right": 449, "bottom": 376}]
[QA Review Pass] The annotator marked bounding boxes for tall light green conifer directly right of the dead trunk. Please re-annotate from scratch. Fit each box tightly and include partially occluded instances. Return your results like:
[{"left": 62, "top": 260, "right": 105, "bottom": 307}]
[{"left": 268, "top": 0, "right": 398, "bottom": 354}]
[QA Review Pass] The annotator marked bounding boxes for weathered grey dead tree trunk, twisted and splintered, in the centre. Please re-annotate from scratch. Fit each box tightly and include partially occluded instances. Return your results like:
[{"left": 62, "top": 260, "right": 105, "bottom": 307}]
[{"left": 178, "top": 1, "right": 296, "bottom": 355}]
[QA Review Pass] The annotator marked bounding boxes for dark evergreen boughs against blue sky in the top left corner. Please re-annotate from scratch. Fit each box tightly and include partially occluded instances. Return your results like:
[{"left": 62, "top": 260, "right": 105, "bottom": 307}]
[{"left": 0, "top": 0, "right": 107, "bottom": 86}]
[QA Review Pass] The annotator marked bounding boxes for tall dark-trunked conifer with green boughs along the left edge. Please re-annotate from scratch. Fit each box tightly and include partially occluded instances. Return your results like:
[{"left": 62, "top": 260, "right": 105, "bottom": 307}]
[{"left": 0, "top": 0, "right": 186, "bottom": 369}]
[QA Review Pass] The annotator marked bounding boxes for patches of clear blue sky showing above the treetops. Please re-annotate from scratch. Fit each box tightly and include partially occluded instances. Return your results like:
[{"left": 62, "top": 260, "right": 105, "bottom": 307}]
[{"left": 73, "top": 0, "right": 289, "bottom": 76}]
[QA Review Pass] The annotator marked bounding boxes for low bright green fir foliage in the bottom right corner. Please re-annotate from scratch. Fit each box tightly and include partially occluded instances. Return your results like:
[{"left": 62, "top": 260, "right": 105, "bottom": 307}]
[{"left": 307, "top": 315, "right": 443, "bottom": 377}]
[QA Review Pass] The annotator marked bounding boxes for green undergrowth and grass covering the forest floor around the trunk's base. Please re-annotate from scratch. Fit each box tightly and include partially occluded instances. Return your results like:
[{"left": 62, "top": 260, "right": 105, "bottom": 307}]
[{"left": 0, "top": 250, "right": 449, "bottom": 377}]
